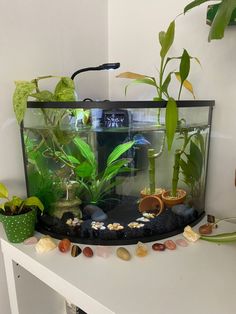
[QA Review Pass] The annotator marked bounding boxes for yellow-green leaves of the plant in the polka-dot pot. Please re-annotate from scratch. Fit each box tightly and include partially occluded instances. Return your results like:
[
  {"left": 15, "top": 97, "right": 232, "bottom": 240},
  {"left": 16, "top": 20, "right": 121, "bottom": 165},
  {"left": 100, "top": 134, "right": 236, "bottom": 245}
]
[{"left": 0, "top": 183, "right": 44, "bottom": 216}]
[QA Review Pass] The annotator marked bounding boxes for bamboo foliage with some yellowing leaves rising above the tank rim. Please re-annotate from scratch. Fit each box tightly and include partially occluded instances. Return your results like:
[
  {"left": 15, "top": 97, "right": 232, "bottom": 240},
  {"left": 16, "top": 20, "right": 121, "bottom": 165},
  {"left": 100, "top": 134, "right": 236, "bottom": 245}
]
[{"left": 117, "top": 21, "right": 199, "bottom": 150}]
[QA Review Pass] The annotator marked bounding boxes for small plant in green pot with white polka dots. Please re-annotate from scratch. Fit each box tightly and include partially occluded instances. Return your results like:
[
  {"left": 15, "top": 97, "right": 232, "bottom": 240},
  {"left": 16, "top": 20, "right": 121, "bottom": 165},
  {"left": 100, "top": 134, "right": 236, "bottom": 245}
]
[{"left": 0, "top": 183, "right": 44, "bottom": 243}]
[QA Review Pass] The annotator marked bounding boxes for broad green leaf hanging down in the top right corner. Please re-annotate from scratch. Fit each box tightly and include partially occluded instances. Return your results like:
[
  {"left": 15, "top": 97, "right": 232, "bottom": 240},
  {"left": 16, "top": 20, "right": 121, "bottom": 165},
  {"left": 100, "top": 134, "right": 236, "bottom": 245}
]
[{"left": 208, "top": 0, "right": 236, "bottom": 41}]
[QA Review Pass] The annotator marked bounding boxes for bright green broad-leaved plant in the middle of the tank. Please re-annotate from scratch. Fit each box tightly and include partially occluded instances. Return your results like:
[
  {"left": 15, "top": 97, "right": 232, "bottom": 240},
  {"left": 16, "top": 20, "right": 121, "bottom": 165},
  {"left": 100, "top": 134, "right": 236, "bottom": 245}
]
[{"left": 73, "top": 137, "right": 135, "bottom": 203}]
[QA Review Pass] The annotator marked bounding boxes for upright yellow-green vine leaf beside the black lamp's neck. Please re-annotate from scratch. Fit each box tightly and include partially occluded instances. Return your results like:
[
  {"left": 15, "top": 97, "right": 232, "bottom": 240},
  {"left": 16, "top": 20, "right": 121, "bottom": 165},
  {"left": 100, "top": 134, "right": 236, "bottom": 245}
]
[{"left": 54, "top": 77, "right": 75, "bottom": 101}]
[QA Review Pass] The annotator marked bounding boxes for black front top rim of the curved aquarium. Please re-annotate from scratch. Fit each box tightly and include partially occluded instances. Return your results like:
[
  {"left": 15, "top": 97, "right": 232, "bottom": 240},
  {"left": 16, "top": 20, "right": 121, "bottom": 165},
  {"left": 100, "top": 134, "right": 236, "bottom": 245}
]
[{"left": 27, "top": 100, "right": 215, "bottom": 109}]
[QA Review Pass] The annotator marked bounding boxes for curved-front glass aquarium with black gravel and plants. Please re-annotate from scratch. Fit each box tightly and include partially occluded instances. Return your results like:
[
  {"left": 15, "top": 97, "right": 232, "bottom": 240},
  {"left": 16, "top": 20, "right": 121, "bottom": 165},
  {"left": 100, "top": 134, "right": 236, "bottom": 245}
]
[{"left": 21, "top": 101, "right": 214, "bottom": 245}]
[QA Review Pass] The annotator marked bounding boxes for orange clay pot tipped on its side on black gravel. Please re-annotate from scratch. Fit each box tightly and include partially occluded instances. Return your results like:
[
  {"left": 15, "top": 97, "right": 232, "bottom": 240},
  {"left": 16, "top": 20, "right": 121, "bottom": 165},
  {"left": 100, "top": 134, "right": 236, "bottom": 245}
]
[{"left": 139, "top": 195, "right": 164, "bottom": 215}]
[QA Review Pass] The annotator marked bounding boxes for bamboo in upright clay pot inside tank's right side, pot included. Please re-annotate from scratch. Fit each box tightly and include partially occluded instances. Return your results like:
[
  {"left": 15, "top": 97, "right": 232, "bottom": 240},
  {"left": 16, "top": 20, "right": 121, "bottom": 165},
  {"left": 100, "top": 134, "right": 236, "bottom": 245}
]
[{"left": 162, "top": 127, "right": 204, "bottom": 207}]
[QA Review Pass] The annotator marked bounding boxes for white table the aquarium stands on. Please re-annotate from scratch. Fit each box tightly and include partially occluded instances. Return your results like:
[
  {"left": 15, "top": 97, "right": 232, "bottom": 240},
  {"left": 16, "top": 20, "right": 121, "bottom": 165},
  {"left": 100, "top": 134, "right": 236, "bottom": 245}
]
[{"left": 0, "top": 222, "right": 236, "bottom": 314}]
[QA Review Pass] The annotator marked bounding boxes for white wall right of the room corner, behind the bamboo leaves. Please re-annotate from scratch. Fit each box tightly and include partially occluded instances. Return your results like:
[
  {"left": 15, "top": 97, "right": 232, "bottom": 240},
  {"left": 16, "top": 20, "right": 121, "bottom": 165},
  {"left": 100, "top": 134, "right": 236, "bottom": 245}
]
[{"left": 108, "top": 0, "right": 236, "bottom": 217}]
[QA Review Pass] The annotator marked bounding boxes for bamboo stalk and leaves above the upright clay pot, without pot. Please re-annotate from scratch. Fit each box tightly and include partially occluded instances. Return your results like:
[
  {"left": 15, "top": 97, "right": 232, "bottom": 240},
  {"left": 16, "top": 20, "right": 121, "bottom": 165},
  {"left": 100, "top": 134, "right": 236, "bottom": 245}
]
[{"left": 171, "top": 128, "right": 205, "bottom": 197}]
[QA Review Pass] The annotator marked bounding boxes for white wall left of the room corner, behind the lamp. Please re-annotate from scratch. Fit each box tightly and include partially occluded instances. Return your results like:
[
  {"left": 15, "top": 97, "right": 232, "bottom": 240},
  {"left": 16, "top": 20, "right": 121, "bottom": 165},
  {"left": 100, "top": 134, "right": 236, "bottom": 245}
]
[{"left": 0, "top": 0, "right": 108, "bottom": 314}]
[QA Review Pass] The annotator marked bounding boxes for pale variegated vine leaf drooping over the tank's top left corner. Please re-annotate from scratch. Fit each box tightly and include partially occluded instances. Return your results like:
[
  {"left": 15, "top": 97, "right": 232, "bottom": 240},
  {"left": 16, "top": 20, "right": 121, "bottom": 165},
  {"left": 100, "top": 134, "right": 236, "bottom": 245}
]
[{"left": 13, "top": 81, "right": 36, "bottom": 124}]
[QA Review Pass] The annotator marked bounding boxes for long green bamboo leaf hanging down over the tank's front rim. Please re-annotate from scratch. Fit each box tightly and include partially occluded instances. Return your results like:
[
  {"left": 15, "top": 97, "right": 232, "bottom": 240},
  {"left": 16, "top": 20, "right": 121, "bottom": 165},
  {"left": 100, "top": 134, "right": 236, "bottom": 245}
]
[{"left": 166, "top": 98, "right": 178, "bottom": 151}]
